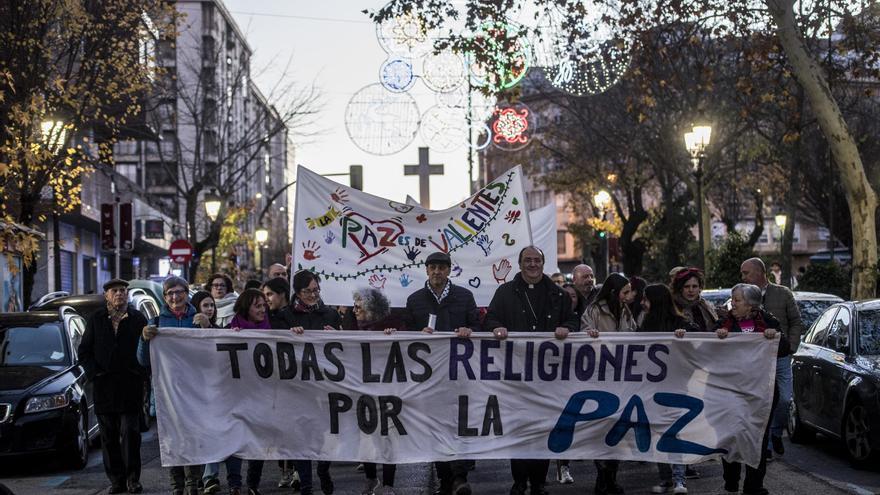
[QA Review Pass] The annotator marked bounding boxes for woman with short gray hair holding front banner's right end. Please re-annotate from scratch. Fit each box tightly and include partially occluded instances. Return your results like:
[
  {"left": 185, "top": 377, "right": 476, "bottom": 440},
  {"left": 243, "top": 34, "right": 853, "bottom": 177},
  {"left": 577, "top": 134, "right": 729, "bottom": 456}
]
[{"left": 715, "top": 284, "right": 785, "bottom": 493}]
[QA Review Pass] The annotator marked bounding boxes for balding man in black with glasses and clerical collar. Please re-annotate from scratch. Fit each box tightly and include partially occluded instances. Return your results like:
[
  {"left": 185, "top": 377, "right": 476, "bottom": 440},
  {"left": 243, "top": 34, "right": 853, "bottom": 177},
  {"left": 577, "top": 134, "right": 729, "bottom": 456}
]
[{"left": 483, "top": 246, "right": 580, "bottom": 495}]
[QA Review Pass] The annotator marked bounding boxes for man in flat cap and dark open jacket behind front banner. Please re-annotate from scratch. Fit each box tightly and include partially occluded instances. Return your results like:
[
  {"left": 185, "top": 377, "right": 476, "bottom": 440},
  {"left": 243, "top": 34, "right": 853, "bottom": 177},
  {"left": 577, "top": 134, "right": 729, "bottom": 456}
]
[{"left": 405, "top": 252, "right": 480, "bottom": 495}]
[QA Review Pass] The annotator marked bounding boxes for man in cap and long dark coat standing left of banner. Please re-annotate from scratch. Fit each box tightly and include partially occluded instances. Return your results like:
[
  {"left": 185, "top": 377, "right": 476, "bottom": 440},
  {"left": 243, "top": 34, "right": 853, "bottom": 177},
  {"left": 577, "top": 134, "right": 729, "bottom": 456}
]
[{"left": 78, "top": 279, "right": 147, "bottom": 493}]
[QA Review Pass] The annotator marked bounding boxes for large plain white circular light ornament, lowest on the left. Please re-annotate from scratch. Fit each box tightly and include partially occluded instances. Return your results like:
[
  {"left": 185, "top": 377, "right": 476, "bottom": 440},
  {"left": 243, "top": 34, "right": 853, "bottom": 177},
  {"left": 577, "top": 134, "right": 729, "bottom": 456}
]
[{"left": 345, "top": 83, "right": 420, "bottom": 156}]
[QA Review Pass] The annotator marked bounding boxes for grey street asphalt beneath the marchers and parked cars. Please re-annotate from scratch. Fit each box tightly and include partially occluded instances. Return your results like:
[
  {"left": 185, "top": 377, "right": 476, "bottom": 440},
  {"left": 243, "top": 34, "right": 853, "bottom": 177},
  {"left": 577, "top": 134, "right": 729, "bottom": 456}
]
[{"left": 0, "top": 426, "right": 880, "bottom": 495}]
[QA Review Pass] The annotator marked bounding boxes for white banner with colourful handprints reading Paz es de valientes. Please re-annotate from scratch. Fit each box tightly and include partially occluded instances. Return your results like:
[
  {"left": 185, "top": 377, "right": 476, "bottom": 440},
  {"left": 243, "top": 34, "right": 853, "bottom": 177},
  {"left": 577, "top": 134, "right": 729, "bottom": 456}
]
[{"left": 293, "top": 166, "right": 532, "bottom": 307}]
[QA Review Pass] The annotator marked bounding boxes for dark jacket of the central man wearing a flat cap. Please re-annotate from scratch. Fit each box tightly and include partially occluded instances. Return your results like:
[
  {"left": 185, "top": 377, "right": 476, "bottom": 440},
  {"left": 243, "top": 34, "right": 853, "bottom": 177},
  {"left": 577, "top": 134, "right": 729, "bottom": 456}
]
[{"left": 406, "top": 284, "right": 480, "bottom": 332}]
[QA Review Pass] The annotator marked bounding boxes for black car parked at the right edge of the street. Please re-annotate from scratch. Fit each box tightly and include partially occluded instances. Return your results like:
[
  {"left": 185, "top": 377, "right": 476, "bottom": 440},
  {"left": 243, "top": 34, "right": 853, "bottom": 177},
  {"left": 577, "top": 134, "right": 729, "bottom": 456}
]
[{"left": 788, "top": 300, "right": 880, "bottom": 466}]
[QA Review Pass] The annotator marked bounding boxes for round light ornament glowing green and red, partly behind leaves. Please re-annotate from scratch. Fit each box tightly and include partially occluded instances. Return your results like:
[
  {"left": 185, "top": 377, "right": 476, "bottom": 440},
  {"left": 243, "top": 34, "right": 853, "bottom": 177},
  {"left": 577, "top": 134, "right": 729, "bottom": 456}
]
[{"left": 468, "top": 22, "right": 532, "bottom": 93}]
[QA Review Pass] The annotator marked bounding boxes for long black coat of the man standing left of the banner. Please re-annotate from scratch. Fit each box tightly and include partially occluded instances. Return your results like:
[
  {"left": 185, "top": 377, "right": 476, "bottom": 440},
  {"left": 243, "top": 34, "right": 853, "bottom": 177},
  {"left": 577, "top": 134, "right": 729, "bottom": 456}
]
[{"left": 77, "top": 307, "right": 147, "bottom": 414}]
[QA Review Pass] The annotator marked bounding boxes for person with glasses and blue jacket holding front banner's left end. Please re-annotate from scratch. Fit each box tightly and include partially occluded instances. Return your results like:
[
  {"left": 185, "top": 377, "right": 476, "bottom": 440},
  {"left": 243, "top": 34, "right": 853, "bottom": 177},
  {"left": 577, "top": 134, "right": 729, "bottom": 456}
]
[{"left": 137, "top": 277, "right": 205, "bottom": 495}]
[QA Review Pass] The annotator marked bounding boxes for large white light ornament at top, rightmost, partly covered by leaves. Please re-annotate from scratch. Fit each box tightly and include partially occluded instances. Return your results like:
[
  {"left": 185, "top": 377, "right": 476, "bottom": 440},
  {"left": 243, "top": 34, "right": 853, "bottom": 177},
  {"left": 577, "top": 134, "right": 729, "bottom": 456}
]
[{"left": 532, "top": 0, "right": 632, "bottom": 96}]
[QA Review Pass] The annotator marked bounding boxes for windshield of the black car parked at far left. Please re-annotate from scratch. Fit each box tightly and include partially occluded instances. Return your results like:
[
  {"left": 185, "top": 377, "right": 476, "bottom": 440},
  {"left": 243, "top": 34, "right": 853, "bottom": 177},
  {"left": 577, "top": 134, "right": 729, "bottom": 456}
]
[{"left": 0, "top": 323, "right": 70, "bottom": 367}]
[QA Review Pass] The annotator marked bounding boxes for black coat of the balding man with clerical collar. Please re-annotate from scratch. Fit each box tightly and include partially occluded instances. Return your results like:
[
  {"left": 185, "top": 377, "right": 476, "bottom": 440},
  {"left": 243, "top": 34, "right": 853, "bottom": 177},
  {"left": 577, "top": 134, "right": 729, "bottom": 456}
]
[{"left": 483, "top": 273, "right": 579, "bottom": 332}]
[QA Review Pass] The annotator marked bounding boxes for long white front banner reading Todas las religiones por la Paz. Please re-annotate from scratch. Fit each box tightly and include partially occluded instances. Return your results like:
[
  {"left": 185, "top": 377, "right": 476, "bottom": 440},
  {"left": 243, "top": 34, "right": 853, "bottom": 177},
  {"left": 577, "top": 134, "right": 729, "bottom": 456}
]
[{"left": 151, "top": 328, "right": 778, "bottom": 466}]
